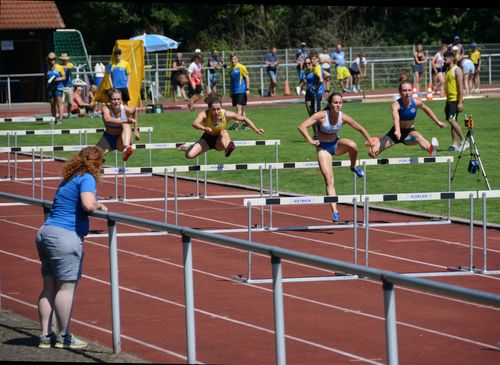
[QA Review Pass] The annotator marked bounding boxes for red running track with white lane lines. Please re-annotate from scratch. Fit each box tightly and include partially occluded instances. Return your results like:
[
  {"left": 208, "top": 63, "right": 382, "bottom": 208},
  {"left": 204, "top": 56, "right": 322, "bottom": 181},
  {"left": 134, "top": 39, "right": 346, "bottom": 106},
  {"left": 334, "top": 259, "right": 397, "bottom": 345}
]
[{"left": 0, "top": 154, "right": 500, "bottom": 365}]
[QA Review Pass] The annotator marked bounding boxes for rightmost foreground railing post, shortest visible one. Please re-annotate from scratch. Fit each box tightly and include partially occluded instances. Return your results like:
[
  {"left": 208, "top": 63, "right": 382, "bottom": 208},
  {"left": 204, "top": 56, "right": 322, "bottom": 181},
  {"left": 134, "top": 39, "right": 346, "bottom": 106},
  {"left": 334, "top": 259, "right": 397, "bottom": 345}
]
[{"left": 382, "top": 281, "right": 399, "bottom": 365}]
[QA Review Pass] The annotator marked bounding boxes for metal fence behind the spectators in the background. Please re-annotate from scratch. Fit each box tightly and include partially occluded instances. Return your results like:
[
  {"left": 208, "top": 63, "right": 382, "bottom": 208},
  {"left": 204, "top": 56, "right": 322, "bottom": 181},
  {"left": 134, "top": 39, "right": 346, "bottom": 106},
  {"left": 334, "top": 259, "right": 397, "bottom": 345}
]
[{"left": 0, "top": 44, "right": 500, "bottom": 105}]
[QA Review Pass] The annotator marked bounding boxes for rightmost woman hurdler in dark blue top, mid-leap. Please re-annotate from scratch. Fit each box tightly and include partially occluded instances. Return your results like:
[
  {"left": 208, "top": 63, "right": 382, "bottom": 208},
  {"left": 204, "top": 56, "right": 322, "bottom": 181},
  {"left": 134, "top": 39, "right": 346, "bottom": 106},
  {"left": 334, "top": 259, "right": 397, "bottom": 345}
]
[{"left": 365, "top": 81, "right": 447, "bottom": 157}]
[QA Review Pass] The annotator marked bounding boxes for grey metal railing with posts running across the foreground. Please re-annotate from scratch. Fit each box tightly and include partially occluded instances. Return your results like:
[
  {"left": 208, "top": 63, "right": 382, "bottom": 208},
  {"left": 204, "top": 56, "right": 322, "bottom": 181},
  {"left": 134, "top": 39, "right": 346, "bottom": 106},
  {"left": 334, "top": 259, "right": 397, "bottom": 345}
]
[{"left": 0, "top": 192, "right": 500, "bottom": 365}]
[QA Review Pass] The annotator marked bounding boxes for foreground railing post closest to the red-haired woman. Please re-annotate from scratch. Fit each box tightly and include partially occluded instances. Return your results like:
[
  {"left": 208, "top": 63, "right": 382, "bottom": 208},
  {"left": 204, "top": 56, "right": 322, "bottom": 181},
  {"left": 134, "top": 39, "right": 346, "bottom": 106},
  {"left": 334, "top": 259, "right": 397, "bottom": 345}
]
[{"left": 108, "top": 219, "right": 121, "bottom": 354}]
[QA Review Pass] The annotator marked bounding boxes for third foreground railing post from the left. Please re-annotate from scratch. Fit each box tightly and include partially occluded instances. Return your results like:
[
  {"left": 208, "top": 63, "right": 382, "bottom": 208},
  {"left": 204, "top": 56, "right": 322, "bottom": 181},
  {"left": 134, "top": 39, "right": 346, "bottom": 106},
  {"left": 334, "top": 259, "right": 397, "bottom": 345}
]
[{"left": 271, "top": 255, "right": 286, "bottom": 365}]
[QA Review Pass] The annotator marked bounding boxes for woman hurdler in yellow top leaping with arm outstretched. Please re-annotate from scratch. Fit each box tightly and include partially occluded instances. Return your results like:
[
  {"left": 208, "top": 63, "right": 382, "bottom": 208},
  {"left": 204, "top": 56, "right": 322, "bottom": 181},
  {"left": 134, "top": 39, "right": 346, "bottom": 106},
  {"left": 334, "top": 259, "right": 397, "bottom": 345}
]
[{"left": 177, "top": 93, "right": 264, "bottom": 159}]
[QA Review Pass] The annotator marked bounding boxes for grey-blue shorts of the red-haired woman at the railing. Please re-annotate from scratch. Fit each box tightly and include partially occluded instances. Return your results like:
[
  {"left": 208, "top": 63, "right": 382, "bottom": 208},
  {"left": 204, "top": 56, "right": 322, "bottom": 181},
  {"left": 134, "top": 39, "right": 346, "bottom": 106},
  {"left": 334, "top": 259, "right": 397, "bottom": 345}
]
[{"left": 35, "top": 225, "right": 84, "bottom": 281}]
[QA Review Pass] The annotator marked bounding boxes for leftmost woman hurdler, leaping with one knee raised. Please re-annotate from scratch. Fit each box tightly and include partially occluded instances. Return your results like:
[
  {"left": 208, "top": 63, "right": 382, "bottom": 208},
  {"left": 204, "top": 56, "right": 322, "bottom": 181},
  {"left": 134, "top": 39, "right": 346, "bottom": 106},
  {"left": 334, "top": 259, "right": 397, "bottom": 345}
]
[{"left": 97, "top": 89, "right": 140, "bottom": 161}]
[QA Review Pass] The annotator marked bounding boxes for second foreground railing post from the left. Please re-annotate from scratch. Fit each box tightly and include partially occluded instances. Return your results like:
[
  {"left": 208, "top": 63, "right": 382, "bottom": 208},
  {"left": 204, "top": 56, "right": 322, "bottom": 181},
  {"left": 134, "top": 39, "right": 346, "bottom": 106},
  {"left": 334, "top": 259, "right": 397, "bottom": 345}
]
[{"left": 182, "top": 234, "right": 196, "bottom": 364}]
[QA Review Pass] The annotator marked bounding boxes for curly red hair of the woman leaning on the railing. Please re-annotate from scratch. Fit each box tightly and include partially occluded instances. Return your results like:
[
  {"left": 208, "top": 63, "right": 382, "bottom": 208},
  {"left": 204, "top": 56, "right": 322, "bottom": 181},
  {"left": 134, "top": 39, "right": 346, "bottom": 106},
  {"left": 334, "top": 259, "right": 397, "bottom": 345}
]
[{"left": 62, "top": 146, "right": 104, "bottom": 181}]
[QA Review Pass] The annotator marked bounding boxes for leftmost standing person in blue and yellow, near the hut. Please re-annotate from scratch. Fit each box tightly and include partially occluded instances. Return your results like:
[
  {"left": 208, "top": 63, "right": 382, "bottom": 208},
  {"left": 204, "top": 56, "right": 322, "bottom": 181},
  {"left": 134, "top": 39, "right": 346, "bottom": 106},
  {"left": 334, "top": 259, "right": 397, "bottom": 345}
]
[{"left": 47, "top": 52, "right": 66, "bottom": 124}]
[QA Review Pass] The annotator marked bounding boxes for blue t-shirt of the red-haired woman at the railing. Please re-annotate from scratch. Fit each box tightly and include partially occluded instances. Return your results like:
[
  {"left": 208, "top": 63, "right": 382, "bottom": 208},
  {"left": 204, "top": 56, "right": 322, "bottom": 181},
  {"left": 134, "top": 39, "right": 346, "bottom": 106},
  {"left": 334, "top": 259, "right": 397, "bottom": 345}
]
[{"left": 45, "top": 173, "right": 96, "bottom": 235}]
